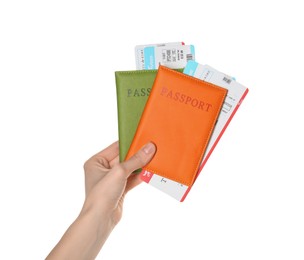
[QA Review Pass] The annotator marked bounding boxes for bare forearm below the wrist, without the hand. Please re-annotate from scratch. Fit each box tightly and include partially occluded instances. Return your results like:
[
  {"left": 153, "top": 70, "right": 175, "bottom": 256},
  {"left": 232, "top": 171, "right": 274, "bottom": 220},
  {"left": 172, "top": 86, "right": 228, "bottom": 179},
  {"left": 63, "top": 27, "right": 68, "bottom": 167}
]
[{"left": 46, "top": 208, "right": 114, "bottom": 260}]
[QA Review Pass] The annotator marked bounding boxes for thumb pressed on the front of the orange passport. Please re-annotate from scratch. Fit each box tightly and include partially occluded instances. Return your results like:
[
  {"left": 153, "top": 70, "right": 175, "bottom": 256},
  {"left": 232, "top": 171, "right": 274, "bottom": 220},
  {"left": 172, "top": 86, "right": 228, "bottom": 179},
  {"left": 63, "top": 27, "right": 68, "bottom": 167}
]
[{"left": 122, "top": 142, "right": 156, "bottom": 176}]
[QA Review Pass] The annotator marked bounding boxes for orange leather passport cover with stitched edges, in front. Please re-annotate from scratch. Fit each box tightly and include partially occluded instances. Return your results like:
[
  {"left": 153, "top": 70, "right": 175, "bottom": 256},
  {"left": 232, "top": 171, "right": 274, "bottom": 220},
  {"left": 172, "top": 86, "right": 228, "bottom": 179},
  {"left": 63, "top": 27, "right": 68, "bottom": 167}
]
[{"left": 126, "top": 65, "right": 227, "bottom": 186}]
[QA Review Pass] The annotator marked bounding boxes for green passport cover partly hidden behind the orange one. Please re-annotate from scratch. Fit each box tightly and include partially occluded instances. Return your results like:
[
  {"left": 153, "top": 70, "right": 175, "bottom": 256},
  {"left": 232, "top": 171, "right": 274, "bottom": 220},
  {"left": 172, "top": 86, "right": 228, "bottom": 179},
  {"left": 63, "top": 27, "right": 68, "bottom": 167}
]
[{"left": 115, "top": 69, "right": 183, "bottom": 161}]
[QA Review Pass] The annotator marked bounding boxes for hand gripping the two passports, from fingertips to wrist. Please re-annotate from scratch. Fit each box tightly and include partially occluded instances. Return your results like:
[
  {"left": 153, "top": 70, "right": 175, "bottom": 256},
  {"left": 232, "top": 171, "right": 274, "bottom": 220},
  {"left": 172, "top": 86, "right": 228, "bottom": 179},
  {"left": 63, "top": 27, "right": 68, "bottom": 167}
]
[{"left": 83, "top": 142, "right": 156, "bottom": 225}]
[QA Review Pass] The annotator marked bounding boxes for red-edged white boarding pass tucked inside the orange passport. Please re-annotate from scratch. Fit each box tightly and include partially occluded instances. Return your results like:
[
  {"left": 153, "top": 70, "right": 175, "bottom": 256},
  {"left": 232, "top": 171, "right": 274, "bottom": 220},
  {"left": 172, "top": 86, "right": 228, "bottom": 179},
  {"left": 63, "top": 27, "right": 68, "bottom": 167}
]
[{"left": 140, "top": 61, "right": 248, "bottom": 201}]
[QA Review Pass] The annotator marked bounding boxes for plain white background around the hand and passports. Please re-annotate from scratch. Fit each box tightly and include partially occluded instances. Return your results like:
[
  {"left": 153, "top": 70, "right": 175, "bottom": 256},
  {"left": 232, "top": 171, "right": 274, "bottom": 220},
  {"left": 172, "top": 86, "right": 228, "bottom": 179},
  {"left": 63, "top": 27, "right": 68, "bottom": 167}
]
[{"left": 0, "top": 0, "right": 304, "bottom": 260}]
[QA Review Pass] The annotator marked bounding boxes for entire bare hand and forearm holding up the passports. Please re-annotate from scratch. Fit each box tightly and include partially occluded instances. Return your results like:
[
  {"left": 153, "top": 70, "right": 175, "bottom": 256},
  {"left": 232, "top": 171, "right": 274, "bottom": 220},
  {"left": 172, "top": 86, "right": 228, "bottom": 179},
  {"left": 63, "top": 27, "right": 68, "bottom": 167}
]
[{"left": 46, "top": 142, "right": 156, "bottom": 260}]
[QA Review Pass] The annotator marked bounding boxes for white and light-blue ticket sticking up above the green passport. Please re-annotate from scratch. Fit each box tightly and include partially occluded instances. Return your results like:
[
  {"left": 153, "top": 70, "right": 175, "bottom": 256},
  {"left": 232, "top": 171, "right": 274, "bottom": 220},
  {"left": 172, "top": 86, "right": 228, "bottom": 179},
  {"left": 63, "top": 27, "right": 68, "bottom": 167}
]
[{"left": 135, "top": 42, "right": 195, "bottom": 70}]
